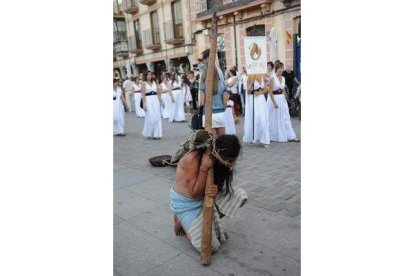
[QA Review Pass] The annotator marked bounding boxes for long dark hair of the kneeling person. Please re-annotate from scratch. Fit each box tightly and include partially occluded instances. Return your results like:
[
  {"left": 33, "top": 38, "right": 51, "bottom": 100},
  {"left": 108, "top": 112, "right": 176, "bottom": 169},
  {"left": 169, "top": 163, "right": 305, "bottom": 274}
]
[{"left": 211, "top": 134, "right": 241, "bottom": 196}]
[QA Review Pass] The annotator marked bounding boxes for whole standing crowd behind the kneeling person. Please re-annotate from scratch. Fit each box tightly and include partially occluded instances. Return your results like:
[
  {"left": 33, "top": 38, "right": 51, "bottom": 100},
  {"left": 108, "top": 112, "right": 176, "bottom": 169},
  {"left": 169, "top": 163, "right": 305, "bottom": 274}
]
[{"left": 113, "top": 49, "right": 300, "bottom": 148}]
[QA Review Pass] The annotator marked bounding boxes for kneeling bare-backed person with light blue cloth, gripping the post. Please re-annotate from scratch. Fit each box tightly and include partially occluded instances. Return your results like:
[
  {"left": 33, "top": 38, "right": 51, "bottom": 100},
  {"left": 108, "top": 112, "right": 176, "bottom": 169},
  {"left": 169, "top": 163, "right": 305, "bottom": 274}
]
[{"left": 170, "top": 130, "right": 247, "bottom": 252}]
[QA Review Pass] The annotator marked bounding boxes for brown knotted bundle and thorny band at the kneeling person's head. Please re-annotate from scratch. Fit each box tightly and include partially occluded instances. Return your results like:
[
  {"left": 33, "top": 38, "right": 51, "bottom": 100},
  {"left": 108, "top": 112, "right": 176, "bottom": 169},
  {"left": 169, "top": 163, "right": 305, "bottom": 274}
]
[{"left": 191, "top": 130, "right": 234, "bottom": 169}]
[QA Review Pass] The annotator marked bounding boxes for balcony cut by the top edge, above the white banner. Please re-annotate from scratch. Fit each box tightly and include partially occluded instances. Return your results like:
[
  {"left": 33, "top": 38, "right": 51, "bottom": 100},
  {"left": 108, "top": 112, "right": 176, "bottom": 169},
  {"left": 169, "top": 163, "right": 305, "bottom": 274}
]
[{"left": 196, "top": 0, "right": 272, "bottom": 23}]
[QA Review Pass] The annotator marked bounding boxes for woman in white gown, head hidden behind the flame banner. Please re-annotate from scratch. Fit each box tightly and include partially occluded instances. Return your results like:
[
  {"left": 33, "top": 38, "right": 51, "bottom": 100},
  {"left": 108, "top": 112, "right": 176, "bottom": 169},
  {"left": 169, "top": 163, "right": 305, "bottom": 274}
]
[{"left": 243, "top": 78, "right": 270, "bottom": 148}]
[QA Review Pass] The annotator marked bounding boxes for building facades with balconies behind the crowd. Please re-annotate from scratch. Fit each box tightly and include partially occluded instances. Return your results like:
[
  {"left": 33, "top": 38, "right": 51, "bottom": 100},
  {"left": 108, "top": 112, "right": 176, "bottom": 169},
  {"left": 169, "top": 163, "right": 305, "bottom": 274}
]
[{"left": 114, "top": 0, "right": 301, "bottom": 78}]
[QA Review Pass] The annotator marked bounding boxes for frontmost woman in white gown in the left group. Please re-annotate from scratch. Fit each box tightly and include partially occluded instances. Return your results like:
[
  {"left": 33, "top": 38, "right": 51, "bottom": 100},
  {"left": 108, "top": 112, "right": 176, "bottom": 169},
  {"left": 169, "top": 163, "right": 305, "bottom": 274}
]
[{"left": 141, "top": 71, "right": 163, "bottom": 139}]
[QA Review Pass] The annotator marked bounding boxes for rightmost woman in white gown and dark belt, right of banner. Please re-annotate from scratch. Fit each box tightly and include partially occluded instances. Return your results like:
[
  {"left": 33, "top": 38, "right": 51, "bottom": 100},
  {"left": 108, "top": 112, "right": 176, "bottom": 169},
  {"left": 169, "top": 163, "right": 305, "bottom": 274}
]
[{"left": 267, "top": 63, "right": 299, "bottom": 142}]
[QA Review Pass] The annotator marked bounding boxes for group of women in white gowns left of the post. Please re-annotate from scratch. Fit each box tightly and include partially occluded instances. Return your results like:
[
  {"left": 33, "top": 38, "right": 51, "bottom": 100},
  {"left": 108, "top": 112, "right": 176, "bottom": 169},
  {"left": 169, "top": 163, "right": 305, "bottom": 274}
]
[{"left": 114, "top": 71, "right": 192, "bottom": 139}]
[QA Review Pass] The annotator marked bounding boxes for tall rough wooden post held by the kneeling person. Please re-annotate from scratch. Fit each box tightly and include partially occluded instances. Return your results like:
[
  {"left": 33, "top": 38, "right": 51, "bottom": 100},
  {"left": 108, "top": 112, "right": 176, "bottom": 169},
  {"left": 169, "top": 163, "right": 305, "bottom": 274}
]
[{"left": 200, "top": 12, "right": 217, "bottom": 265}]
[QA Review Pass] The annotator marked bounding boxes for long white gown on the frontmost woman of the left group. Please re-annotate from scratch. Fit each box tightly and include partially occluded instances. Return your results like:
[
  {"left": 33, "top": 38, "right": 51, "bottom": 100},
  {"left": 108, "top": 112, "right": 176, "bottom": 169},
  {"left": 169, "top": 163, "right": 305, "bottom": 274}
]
[{"left": 142, "top": 82, "right": 162, "bottom": 138}]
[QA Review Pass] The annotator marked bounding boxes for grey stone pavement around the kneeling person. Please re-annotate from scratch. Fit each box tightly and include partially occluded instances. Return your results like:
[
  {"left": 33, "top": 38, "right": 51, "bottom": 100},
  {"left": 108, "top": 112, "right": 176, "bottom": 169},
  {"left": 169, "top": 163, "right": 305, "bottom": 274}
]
[{"left": 113, "top": 113, "right": 301, "bottom": 276}]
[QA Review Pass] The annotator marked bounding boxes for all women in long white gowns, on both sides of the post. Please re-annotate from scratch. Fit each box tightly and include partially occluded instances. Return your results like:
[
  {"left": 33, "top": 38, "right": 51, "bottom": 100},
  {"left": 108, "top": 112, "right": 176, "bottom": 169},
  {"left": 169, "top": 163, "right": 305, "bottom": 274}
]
[{"left": 114, "top": 62, "right": 299, "bottom": 148}]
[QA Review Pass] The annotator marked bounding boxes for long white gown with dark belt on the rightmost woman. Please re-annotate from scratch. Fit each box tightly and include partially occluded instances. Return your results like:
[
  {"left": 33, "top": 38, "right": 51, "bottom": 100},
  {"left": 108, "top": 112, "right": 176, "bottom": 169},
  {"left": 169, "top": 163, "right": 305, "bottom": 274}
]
[{"left": 267, "top": 77, "right": 296, "bottom": 142}]
